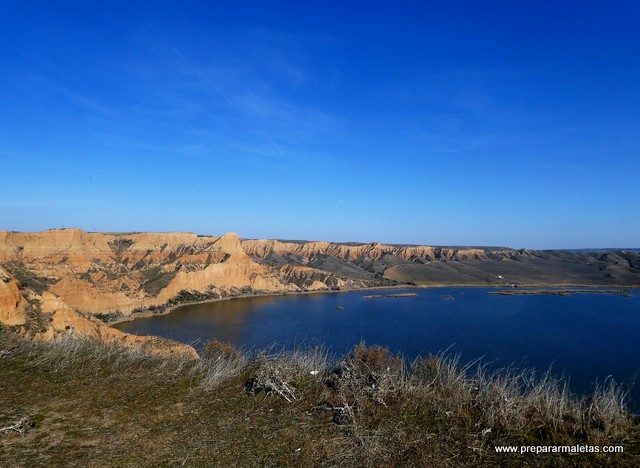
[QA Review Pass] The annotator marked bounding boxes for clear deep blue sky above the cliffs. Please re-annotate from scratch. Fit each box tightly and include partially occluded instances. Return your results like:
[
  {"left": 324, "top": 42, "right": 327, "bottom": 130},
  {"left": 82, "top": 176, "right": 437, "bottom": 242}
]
[{"left": 0, "top": 0, "right": 640, "bottom": 248}]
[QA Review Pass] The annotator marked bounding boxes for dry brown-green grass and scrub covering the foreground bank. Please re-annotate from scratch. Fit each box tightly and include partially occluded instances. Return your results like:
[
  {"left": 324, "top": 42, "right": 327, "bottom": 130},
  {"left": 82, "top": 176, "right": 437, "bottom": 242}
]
[{"left": 0, "top": 330, "right": 640, "bottom": 466}]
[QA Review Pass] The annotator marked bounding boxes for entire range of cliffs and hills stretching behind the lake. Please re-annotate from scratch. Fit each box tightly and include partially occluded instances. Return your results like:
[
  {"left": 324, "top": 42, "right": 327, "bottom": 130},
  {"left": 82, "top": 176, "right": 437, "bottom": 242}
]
[{"left": 0, "top": 229, "right": 640, "bottom": 350}]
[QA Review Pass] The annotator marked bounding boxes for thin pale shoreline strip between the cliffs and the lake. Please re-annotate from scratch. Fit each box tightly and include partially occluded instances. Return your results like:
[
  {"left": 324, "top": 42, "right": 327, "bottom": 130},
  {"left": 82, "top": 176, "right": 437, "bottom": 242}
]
[{"left": 104, "top": 283, "right": 640, "bottom": 327}]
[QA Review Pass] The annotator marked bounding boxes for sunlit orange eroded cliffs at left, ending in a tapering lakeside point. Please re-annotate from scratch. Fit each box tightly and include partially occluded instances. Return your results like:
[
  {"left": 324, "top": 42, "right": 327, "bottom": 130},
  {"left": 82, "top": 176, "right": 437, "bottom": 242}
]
[{"left": 0, "top": 229, "right": 392, "bottom": 345}]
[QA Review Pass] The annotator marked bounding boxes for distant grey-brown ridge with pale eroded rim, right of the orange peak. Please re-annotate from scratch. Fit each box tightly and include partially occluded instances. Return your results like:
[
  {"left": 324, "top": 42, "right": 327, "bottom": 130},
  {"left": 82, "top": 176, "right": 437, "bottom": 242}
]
[{"left": 242, "top": 240, "right": 640, "bottom": 286}]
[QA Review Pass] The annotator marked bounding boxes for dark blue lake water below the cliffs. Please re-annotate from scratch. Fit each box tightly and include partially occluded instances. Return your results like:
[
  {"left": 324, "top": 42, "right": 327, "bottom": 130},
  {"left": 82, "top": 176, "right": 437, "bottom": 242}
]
[{"left": 116, "top": 288, "right": 640, "bottom": 408}]
